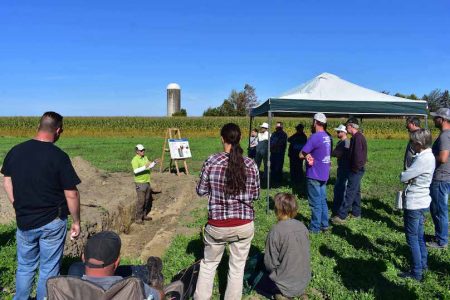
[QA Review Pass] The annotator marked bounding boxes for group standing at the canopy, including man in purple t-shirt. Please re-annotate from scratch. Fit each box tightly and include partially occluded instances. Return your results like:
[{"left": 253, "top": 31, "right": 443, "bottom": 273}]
[{"left": 249, "top": 113, "right": 367, "bottom": 233}]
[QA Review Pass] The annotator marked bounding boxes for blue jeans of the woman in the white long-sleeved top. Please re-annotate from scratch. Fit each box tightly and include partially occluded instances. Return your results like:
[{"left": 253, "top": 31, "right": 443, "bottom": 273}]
[{"left": 403, "top": 208, "right": 428, "bottom": 280}]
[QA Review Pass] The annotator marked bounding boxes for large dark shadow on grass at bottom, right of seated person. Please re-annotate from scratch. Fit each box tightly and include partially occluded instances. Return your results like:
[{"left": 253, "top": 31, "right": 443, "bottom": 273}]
[{"left": 319, "top": 245, "right": 417, "bottom": 299}]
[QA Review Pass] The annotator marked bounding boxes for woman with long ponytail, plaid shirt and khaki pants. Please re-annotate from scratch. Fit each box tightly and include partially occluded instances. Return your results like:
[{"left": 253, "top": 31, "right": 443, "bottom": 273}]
[{"left": 194, "top": 123, "right": 259, "bottom": 300}]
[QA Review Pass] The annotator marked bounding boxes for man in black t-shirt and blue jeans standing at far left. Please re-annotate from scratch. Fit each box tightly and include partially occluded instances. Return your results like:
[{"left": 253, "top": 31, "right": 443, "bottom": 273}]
[{"left": 1, "top": 112, "right": 81, "bottom": 300}]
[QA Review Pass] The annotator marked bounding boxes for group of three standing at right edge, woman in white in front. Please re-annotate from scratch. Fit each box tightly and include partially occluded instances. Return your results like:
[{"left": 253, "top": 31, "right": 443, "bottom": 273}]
[{"left": 399, "top": 108, "right": 450, "bottom": 281}]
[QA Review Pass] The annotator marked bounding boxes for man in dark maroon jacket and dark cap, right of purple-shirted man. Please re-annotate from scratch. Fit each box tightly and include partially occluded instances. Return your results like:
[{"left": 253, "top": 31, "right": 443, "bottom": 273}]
[{"left": 331, "top": 118, "right": 367, "bottom": 224}]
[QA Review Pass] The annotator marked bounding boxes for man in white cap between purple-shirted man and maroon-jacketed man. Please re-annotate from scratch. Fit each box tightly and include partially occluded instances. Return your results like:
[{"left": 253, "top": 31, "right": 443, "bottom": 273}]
[{"left": 331, "top": 124, "right": 350, "bottom": 215}]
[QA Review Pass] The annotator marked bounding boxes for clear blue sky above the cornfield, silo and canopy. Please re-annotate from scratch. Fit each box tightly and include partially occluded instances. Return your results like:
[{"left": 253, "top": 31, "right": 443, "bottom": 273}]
[{"left": 0, "top": 0, "right": 450, "bottom": 116}]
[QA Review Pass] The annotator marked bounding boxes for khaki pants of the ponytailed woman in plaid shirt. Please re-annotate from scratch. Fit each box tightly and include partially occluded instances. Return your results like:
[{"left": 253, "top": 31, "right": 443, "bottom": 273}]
[{"left": 194, "top": 222, "right": 254, "bottom": 300}]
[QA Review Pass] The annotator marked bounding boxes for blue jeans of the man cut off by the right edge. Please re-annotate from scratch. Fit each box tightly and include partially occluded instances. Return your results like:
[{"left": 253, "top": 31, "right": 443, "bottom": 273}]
[{"left": 430, "top": 180, "right": 450, "bottom": 246}]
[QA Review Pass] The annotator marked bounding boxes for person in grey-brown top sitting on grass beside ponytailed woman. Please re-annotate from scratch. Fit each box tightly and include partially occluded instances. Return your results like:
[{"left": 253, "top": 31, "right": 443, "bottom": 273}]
[{"left": 255, "top": 193, "right": 311, "bottom": 299}]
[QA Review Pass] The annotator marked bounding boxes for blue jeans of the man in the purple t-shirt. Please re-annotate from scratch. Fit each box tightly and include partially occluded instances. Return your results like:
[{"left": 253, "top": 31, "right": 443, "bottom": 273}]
[{"left": 306, "top": 178, "right": 328, "bottom": 233}]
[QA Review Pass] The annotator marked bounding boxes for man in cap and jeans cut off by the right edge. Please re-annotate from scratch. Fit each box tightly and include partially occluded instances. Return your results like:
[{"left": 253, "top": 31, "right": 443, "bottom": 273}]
[{"left": 427, "top": 108, "right": 450, "bottom": 249}]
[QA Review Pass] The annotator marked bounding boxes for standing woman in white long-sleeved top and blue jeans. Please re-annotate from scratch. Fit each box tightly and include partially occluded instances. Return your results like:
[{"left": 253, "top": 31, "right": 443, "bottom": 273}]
[{"left": 399, "top": 129, "right": 436, "bottom": 281}]
